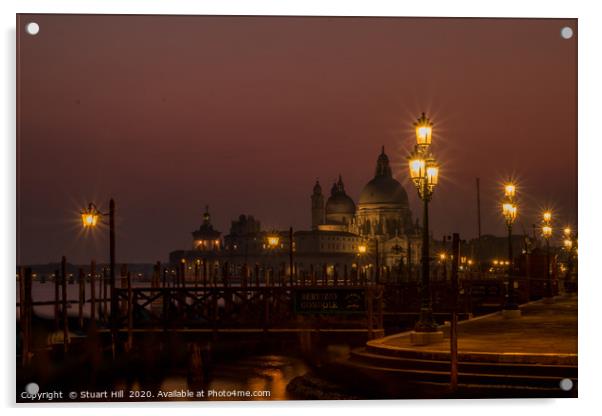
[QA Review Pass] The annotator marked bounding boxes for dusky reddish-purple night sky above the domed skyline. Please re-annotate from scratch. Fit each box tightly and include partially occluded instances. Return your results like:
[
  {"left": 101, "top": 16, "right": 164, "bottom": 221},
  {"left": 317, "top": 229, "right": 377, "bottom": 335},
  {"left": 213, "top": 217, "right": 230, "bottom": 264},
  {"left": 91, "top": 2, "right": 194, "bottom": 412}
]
[{"left": 17, "top": 15, "right": 577, "bottom": 264}]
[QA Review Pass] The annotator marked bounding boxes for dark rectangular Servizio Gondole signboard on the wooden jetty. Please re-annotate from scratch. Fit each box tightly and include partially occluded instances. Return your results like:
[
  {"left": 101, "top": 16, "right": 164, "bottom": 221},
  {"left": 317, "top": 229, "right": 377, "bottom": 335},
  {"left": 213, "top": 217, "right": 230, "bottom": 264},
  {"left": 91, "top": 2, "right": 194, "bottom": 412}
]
[{"left": 294, "top": 288, "right": 366, "bottom": 314}]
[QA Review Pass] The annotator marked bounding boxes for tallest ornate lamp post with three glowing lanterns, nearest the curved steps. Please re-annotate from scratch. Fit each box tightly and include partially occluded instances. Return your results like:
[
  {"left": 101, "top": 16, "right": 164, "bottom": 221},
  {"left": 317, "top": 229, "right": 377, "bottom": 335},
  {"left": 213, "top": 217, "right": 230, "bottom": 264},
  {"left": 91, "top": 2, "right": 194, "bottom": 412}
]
[{"left": 408, "top": 113, "right": 439, "bottom": 333}]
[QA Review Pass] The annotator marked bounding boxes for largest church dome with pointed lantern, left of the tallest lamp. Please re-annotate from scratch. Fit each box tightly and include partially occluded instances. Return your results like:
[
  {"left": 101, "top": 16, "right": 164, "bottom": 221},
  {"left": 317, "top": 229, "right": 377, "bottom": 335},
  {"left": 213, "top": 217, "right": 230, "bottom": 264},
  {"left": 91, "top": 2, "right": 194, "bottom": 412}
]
[{"left": 359, "top": 147, "right": 408, "bottom": 206}]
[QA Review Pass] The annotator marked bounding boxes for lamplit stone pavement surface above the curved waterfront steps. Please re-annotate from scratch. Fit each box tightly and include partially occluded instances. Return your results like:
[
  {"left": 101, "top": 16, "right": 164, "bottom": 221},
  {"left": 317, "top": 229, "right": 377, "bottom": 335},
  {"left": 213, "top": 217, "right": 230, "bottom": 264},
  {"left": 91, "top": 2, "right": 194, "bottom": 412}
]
[{"left": 367, "top": 296, "right": 577, "bottom": 365}]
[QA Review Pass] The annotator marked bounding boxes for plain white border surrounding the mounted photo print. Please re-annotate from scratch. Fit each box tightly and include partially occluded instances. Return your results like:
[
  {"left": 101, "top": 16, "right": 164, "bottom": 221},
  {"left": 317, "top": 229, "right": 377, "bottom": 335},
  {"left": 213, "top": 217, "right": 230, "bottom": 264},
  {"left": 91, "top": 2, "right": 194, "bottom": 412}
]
[{"left": 0, "top": 0, "right": 602, "bottom": 415}]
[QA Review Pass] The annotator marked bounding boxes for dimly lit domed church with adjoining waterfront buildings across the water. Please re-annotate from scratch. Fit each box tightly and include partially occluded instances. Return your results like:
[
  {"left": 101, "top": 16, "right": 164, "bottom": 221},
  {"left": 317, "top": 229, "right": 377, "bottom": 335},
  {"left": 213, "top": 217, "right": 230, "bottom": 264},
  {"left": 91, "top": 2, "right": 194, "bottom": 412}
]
[{"left": 170, "top": 147, "right": 421, "bottom": 281}]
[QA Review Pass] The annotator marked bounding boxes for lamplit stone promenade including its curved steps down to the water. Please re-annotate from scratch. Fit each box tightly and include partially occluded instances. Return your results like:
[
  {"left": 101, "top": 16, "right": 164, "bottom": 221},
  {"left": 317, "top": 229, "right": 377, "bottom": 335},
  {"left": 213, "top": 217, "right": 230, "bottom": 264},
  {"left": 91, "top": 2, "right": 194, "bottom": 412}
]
[{"left": 338, "top": 296, "right": 578, "bottom": 398}]
